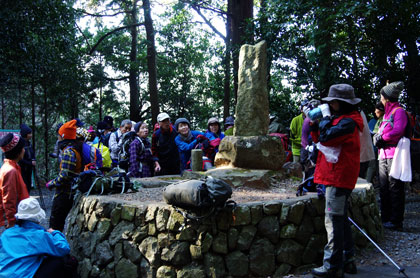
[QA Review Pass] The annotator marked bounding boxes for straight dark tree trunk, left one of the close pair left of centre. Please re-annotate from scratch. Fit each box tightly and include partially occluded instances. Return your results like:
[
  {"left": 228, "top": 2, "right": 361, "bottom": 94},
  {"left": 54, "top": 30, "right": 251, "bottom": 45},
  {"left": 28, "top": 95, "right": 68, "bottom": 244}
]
[{"left": 129, "top": 0, "right": 140, "bottom": 122}]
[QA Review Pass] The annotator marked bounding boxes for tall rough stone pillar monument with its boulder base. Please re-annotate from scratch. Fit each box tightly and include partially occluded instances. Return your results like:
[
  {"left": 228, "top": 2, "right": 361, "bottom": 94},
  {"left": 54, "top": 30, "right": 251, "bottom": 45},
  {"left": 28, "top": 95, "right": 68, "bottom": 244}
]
[{"left": 215, "top": 41, "right": 285, "bottom": 170}]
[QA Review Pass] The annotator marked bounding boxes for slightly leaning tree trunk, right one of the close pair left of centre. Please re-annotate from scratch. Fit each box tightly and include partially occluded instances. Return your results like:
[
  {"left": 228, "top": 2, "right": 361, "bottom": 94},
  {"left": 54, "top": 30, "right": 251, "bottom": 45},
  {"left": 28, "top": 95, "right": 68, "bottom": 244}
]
[{"left": 143, "top": 0, "right": 159, "bottom": 126}]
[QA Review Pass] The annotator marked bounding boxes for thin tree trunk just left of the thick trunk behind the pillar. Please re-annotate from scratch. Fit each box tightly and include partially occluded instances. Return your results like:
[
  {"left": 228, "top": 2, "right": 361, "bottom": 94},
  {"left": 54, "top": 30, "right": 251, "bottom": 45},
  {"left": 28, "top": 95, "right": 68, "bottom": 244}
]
[{"left": 223, "top": 6, "right": 232, "bottom": 119}]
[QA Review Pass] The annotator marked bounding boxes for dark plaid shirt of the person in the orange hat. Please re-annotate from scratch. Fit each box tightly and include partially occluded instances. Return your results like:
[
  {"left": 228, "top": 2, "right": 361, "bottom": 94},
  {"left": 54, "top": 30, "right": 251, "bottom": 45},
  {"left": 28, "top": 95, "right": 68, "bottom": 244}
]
[{"left": 50, "top": 147, "right": 77, "bottom": 189}]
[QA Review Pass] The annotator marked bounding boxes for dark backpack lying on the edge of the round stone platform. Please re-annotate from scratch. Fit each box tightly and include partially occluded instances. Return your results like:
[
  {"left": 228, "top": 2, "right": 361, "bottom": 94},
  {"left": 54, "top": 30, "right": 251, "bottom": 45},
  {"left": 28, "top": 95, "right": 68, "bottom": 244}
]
[{"left": 163, "top": 176, "right": 234, "bottom": 220}]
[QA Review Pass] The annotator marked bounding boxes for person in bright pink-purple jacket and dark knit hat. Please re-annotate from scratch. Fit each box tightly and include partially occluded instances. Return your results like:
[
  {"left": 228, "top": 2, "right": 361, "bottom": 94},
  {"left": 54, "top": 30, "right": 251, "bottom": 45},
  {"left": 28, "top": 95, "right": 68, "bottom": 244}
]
[{"left": 374, "top": 81, "right": 408, "bottom": 230}]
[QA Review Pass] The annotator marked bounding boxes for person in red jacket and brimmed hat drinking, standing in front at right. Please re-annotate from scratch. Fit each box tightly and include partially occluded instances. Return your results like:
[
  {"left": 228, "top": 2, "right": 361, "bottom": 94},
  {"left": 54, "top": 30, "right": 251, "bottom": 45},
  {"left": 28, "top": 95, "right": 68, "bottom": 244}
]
[{"left": 311, "top": 84, "right": 363, "bottom": 277}]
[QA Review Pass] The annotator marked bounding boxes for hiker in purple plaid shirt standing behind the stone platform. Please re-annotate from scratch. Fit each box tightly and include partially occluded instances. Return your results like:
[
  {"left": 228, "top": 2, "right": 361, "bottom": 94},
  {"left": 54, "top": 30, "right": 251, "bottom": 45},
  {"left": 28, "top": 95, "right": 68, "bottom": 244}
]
[{"left": 128, "top": 122, "right": 160, "bottom": 178}]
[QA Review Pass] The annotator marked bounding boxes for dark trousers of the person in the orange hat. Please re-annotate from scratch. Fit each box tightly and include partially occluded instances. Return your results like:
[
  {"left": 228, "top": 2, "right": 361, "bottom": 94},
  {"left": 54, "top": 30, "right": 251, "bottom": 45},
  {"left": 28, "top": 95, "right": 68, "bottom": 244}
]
[{"left": 50, "top": 190, "right": 73, "bottom": 232}]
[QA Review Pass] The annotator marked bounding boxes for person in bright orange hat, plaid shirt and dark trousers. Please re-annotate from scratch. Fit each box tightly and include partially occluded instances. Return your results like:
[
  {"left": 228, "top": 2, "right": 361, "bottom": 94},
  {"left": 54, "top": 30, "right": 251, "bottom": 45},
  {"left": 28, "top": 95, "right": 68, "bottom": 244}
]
[{"left": 46, "top": 120, "right": 83, "bottom": 232}]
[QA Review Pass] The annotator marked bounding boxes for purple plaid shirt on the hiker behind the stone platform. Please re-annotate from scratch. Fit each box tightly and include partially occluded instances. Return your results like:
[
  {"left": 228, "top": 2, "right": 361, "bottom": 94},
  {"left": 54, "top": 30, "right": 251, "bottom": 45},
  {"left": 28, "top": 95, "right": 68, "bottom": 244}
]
[{"left": 128, "top": 137, "right": 154, "bottom": 178}]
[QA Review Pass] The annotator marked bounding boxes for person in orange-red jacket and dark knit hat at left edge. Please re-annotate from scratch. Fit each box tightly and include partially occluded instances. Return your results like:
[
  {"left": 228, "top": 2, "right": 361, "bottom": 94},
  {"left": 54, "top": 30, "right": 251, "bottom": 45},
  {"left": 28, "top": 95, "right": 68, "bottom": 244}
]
[{"left": 0, "top": 133, "right": 29, "bottom": 229}]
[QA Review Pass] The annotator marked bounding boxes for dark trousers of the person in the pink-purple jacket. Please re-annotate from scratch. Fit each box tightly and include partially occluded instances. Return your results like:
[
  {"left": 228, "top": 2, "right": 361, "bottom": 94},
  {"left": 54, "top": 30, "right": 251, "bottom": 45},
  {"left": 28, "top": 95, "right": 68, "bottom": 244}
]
[{"left": 379, "top": 158, "right": 405, "bottom": 225}]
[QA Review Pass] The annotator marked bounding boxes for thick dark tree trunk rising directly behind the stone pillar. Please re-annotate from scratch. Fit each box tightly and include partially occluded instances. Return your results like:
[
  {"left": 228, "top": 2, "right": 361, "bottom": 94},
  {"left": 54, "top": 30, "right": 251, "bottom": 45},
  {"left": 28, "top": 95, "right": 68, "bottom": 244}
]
[{"left": 228, "top": 0, "right": 254, "bottom": 103}]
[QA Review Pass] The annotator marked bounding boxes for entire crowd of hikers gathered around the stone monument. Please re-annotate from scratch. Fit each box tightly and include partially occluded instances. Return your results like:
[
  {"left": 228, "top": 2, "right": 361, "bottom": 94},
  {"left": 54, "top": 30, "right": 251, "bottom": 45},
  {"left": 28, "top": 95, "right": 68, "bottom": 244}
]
[{"left": 0, "top": 82, "right": 418, "bottom": 277}]
